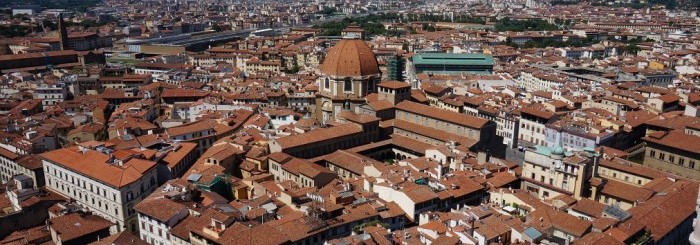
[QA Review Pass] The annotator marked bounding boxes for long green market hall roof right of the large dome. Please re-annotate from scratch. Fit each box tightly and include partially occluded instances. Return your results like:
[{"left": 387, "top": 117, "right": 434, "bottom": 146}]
[{"left": 413, "top": 53, "right": 494, "bottom": 65}]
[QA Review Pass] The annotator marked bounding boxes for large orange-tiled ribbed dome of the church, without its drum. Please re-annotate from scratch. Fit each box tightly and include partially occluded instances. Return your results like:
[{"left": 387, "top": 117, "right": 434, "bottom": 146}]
[{"left": 320, "top": 39, "right": 381, "bottom": 77}]
